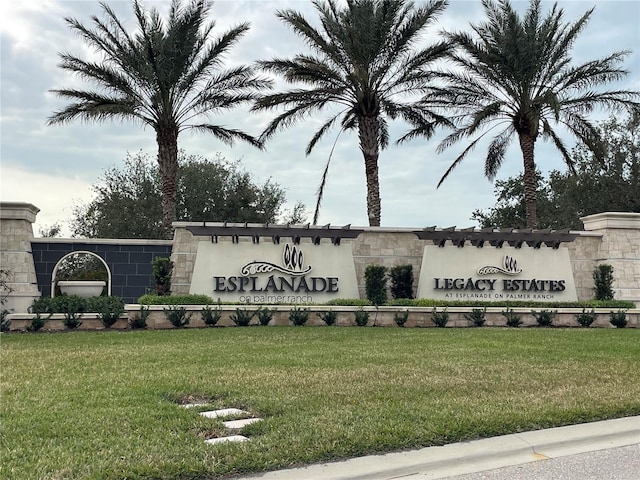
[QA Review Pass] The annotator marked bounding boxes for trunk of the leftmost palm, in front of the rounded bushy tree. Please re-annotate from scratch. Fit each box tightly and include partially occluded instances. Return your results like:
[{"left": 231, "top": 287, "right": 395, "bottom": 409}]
[{"left": 156, "top": 127, "right": 178, "bottom": 239}]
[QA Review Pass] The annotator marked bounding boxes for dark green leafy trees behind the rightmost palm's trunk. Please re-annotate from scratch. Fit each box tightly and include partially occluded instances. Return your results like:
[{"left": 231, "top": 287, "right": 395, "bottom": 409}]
[{"left": 472, "top": 116, "right": 640, "bottom": 230}]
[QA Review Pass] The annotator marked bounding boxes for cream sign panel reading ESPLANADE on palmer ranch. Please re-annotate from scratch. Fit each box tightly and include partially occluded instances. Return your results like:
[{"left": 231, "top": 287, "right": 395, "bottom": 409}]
[{"left": 189, "top": 241, "right": 358, "bottom": 304}]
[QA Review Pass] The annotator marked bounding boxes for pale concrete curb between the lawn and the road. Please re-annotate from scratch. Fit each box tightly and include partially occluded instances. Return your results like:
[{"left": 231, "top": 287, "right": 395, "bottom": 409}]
[{"left": 242, "top": 416, "right": 640, "bottom": 480}]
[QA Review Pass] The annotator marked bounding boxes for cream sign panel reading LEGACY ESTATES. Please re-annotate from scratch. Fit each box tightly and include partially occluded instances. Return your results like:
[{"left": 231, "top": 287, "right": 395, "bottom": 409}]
[{"left": 418, "top": 245, "right": 578, "bottom": 302}]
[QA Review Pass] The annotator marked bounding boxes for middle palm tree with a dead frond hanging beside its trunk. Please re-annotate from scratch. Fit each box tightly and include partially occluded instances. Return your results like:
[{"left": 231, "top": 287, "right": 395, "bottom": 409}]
[{"left": 254, "top": 0, "right": 449, "bottom": 226}]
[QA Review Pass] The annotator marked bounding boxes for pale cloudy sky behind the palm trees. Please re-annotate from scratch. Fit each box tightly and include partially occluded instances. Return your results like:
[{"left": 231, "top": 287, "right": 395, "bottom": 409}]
[{"left": 0, "top": 0, "right": 640, "bottom": 236}]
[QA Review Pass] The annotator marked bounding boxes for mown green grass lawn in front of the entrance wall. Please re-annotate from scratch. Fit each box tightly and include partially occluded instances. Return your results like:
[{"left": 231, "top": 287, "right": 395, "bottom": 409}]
[{"left": 0, "top": 327, "right": 640, "bottom": 479}]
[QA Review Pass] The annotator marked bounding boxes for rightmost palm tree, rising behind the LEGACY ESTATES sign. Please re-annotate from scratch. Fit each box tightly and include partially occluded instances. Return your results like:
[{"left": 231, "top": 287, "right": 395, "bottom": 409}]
[{"left": 430, "top": 0, "right": 639, "bottom": 228}]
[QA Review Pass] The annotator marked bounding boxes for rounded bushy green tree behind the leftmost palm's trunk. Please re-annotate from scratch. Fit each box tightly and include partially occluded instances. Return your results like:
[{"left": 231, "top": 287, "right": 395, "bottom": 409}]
[{"left": 71, "top": 152, "right": 304, "bottom": 238}]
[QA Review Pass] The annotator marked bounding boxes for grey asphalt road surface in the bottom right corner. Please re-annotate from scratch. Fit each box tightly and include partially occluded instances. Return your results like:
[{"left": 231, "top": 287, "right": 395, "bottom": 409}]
[{"left": 442, "top": 443, "right": 640, "bottom": 480}]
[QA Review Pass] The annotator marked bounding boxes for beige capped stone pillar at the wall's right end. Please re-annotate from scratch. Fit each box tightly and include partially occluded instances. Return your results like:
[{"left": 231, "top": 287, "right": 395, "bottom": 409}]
[{"left": 580, "top": 212, "right": 640, "bottom": 308}]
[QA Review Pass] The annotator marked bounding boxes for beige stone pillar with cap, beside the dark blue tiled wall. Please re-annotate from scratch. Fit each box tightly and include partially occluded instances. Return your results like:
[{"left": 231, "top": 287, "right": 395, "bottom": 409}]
[{"left": 0, "top": 202, "right": 40, "bottom": 313}]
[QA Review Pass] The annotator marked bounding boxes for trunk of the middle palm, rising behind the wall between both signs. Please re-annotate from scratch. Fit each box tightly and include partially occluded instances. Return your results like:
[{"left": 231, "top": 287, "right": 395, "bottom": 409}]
[{"left": 358, "top": 116, "right": 380, "bottom": 227}]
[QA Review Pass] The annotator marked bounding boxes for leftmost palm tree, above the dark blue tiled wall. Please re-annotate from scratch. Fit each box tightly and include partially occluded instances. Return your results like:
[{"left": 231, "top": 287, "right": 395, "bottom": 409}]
[{"left": 48, "top": 0, "right": 270, "bottom": 235}]
